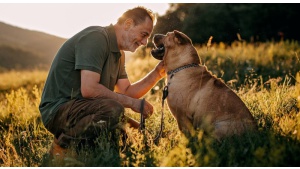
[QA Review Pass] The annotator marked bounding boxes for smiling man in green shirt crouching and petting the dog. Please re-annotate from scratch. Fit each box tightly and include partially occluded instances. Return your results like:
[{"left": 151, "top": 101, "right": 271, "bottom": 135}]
[{"left": 39, "top": 7, "right": 165, "bottom": 156}]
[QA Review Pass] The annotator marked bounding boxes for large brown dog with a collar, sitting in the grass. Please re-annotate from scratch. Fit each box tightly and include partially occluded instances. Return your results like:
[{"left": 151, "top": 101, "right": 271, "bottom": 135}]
[{"left": 151, "top": 31, "right": 256, "bottom": 139}]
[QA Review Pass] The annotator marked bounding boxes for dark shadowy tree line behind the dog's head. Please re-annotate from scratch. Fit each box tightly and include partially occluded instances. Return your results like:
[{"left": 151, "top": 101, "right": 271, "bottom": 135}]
[{"left": 153, "top": 3, "right": 300, "bottom": 44}]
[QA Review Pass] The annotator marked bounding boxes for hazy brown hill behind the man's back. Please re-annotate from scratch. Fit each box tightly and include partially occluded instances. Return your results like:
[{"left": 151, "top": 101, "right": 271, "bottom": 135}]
[{"left": 0, "top": 22, "right": 66, "bottom": 71}]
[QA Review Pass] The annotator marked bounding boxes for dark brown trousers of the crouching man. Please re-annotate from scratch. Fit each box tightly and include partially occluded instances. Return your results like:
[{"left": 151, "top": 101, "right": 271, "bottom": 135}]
[{"left": 46, "top": 98, "right": 124, "bottom": 147}]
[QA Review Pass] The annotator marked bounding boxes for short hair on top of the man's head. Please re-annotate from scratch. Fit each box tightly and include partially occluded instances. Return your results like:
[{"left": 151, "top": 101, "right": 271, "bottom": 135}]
[{"left": 117, "top": 6, "right": 156, "bottom": 26}]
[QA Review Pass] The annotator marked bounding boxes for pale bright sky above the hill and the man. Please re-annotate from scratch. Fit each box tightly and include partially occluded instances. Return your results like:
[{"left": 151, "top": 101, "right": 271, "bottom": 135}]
[{"left": 0, "top": 0, "right": 169, "bottom": 38}]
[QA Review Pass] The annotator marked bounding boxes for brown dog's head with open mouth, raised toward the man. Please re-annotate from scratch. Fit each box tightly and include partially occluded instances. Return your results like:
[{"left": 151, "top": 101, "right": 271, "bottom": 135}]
[{"left": 151, "top": 30, "right": 200, "bottom": 63}]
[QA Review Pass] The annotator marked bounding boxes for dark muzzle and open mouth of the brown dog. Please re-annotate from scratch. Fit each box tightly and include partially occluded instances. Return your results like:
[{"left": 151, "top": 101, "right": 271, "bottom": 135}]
[{"left": 151, "top": 34, "right": 165, "bottom": 60}]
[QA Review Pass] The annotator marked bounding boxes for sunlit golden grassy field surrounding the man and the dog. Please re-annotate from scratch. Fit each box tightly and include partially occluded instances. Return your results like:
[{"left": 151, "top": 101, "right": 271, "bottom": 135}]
[{"left": 0, "top": 41, "right": 300, "bottom": 167}]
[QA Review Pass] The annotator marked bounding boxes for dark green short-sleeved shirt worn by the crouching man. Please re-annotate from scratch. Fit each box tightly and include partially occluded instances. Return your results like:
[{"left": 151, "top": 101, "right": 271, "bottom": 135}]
[{"left": 39, "top": 25, "right": 127, "bottom": 125}]
